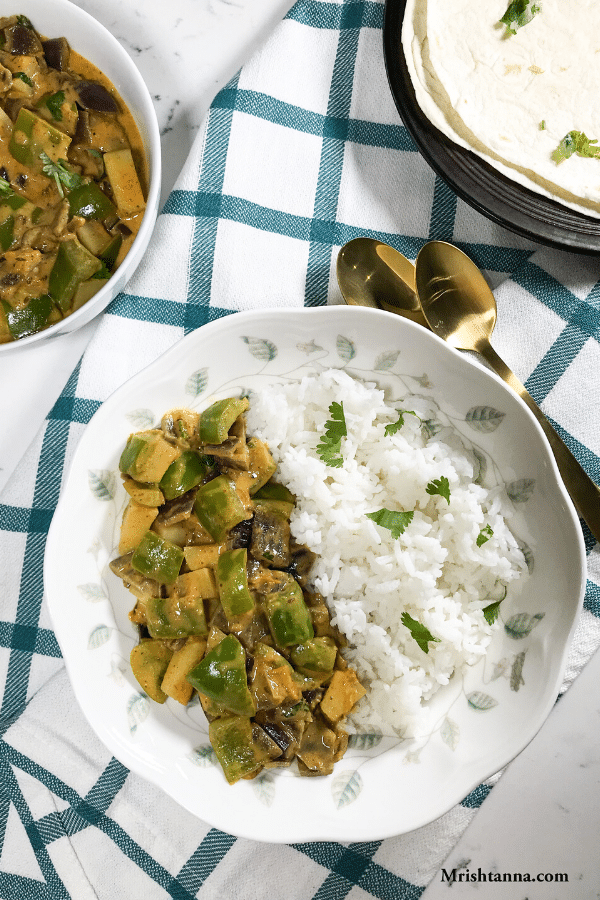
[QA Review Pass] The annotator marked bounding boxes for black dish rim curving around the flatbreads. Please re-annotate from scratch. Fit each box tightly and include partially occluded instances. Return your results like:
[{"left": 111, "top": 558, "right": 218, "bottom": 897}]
[{"left": 383, "top": 0, "right": 600, "bottom": 254}]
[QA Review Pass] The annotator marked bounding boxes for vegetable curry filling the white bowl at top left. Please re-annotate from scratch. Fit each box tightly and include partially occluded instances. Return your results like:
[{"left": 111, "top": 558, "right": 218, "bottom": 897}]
[{"left": 0, "top": 15, "right": 147, "bottom": 343}]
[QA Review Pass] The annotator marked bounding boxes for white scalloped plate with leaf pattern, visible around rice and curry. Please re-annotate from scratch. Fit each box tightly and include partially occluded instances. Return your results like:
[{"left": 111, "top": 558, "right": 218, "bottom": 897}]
[{"left": 44, "top": 306, "right": 585, "bottom": 842}]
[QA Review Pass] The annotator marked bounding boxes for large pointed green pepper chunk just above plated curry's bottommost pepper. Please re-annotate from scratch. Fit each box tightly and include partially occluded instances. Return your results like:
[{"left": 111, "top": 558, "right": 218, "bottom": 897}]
[{"left": 187, "top": 634, "right": 256, "bottom": 716}]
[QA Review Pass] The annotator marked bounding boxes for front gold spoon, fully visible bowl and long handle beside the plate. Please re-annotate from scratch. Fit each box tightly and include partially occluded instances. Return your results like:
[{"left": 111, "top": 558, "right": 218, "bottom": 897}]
[{"left": 416, "top": 241, "right": 600, "bottom": 541}]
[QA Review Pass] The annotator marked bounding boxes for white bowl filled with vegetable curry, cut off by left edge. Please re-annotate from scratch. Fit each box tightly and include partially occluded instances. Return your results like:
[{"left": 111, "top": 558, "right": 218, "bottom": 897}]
[{"left": 0, "top": 0, "right": 161, "bottom": 353}]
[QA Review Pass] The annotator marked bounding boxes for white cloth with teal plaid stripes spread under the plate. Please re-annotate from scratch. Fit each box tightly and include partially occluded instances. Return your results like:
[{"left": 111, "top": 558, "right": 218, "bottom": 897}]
[{"left": 0, "top": 0, "right": 600, "bottom": 900}]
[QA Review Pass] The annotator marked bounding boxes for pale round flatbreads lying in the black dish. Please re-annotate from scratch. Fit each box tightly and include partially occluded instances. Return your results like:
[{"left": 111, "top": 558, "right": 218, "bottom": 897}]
[{"left": 402, "top": 0, "right": 600, "bottom": 218}]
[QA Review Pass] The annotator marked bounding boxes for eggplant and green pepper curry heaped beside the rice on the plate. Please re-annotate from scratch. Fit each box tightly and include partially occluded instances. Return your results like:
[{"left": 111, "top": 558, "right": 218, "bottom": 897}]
[{"left": 110, "top": 398, "right": 366, "bottom": 784}]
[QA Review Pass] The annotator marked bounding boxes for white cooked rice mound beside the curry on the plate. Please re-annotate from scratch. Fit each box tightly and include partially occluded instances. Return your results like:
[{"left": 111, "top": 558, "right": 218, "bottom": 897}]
[{"left": 247, "top": 369, "right": 526, "bottom": 737}]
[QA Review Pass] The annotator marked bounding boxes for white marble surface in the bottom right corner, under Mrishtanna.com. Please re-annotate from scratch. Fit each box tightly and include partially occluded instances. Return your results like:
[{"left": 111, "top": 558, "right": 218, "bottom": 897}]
[{"left": 422, "top": 653, "right": 600, "bottom": 900}]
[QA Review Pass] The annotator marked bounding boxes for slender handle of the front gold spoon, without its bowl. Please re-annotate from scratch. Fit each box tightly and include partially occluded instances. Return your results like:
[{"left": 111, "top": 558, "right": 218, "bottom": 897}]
[{"left": 478, "top": 343, "right": 600, "bottom": 542}]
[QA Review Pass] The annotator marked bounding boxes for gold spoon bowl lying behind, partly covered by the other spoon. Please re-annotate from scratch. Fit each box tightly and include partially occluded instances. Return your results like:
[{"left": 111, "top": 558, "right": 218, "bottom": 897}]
[{"left": 337, "top": 238, "right": 428, "bottom": 328}]
